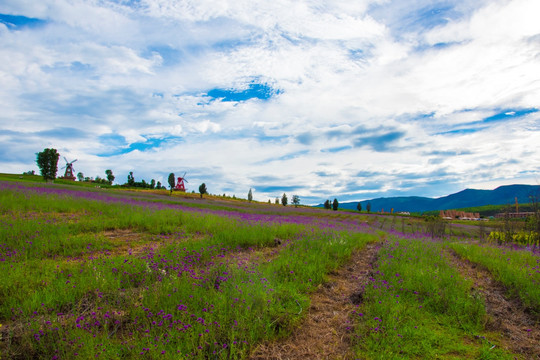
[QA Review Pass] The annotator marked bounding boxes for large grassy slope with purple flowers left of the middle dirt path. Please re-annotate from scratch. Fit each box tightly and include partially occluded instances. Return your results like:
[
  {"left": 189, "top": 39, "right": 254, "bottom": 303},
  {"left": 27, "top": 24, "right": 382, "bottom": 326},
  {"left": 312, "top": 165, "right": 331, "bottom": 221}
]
[{"left": 0, "top": 181, "right": 376, "bottom": 359}]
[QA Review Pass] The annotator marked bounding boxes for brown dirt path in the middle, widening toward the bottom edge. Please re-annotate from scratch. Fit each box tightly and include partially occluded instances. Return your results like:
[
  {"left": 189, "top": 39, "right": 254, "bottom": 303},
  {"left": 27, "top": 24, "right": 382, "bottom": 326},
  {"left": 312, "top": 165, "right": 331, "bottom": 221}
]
[{"left": 251, "top": 244, "right": 379, "bottom": 360}]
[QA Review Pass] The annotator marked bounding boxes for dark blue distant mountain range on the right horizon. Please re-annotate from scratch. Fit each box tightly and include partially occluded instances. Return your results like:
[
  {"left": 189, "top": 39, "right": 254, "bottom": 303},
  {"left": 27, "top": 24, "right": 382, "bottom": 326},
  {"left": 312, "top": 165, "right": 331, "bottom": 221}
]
[{"left": 317, "top": 185, "right": 540, "bottom": 212}]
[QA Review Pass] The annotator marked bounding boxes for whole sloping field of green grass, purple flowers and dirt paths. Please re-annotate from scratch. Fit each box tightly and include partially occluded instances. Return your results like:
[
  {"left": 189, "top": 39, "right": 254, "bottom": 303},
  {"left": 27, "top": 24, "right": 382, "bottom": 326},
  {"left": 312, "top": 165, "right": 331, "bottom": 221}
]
[{"left": 0, "top": 180, "right": 540, "bottom": 359}]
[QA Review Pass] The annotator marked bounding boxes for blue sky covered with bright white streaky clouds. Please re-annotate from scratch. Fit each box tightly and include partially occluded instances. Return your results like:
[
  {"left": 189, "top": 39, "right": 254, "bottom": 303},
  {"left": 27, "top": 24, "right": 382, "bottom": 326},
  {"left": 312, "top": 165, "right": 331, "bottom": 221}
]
[{"left": 0, "top": 0, "right": 540, "bottom": 204}]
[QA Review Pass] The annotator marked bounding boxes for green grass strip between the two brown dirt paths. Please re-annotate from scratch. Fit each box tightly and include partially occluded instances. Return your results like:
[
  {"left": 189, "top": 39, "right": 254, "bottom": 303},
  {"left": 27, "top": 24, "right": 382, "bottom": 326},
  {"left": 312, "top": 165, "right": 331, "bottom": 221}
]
[{"left": 356, "top": 239, "right": 511, "bottom": 359}]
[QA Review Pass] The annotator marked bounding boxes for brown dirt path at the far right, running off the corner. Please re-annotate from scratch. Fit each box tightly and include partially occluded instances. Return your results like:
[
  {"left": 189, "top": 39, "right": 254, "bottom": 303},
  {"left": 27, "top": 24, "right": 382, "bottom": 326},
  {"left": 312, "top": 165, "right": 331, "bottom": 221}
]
[{"left": 448, "top": 250, "right": 540, "bottom": 359}]
